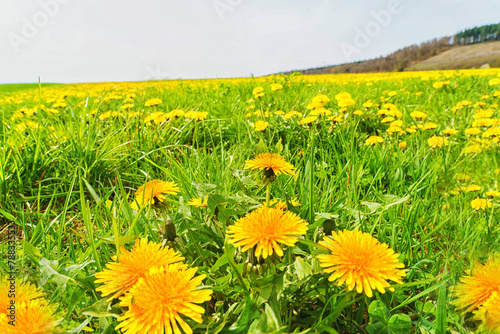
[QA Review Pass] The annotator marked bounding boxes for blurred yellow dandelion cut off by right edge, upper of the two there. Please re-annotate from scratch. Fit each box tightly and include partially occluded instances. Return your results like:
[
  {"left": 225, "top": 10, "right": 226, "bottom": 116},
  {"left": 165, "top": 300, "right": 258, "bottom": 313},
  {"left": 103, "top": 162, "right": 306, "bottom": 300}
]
[{"left": 453, "top": 254, "right": 500, "bottom": 313}]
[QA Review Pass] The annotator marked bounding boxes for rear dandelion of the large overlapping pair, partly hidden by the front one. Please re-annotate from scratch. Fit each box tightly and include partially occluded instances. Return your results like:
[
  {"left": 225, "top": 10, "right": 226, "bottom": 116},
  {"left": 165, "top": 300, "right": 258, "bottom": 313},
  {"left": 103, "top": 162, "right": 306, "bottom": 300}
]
[{"left": 95, "top": 238, "right": 184, "bottom": 301}]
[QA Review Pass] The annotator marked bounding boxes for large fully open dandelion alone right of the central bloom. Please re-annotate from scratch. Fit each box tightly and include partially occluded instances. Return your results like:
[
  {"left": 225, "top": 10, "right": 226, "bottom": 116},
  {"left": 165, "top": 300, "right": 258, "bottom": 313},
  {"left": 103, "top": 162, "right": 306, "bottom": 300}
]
[{"left": 318, "top": 230, "right": 405, "bottom": 297}]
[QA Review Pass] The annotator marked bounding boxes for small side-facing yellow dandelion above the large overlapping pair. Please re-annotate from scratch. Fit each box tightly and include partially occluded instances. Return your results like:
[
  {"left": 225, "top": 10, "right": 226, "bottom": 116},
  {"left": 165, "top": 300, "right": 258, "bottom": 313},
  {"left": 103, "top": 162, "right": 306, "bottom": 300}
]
[{"left": 130, "top": 180, "right": 181, "bottom": 210}]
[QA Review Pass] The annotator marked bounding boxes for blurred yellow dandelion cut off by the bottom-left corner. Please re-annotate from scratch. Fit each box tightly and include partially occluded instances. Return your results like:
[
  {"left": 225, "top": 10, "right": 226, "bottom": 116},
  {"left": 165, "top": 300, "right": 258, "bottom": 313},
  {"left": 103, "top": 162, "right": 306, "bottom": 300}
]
[{"left": 0, "top": 298, "right": 58, "bottom": 334}]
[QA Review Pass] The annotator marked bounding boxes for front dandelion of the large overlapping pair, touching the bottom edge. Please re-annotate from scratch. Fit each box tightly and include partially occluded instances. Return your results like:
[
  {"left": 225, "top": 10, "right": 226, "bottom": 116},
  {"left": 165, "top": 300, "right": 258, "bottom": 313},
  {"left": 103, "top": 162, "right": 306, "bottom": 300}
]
[{"left": 115, "top": 263, "right": 213, "bottom": 334}]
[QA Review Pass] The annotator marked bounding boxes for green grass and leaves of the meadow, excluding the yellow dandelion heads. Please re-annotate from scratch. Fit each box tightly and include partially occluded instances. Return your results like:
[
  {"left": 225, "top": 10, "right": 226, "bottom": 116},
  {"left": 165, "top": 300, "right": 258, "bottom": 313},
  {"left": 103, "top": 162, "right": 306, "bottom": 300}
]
[{"left": 0, "top": 70, "right": 500, "bottom": 333}]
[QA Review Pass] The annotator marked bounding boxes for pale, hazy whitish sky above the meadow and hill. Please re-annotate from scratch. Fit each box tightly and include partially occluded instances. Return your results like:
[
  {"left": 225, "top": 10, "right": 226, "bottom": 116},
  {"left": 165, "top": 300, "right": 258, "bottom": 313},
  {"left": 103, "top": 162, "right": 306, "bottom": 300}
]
[{"left": 0, "top": 0, "right": 500, "bottom": 84}]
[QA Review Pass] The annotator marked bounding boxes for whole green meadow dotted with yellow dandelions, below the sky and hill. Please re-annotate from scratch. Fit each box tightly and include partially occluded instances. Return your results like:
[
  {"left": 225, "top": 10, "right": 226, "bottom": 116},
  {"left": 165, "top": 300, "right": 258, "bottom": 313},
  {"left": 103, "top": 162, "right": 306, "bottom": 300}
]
[{"left": 0, "top": 69, "right": 500, "bottom": 334}]
